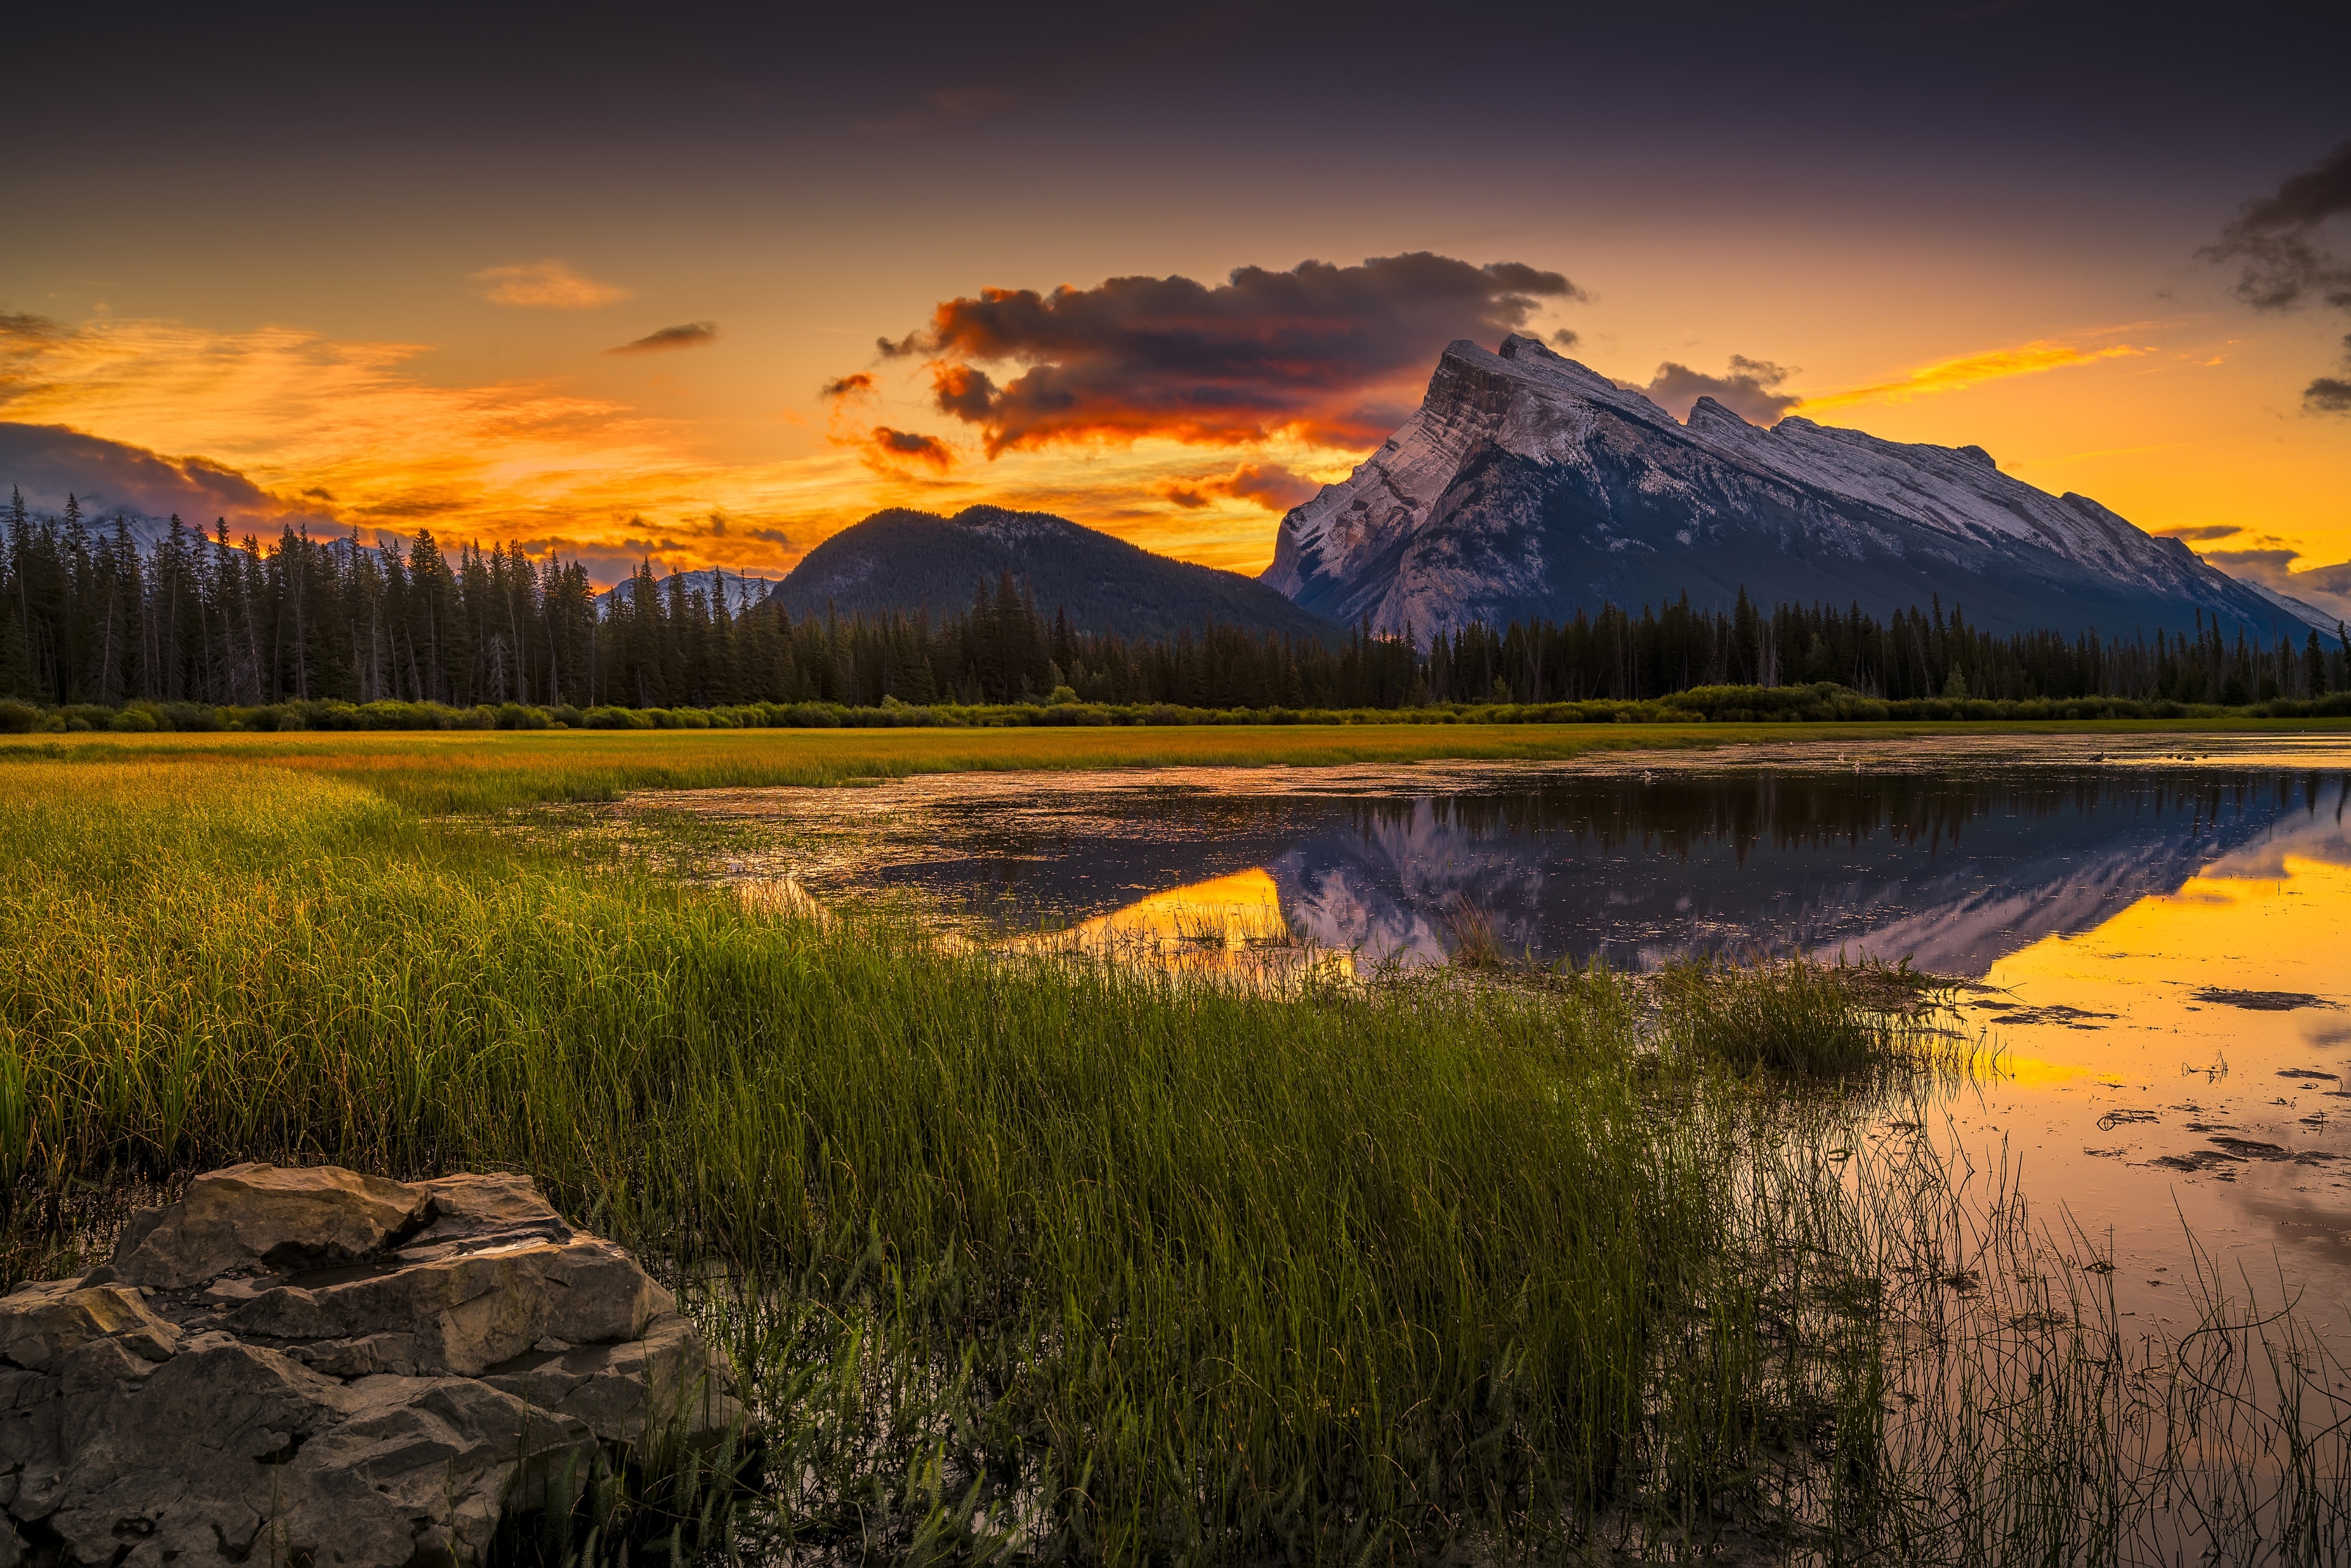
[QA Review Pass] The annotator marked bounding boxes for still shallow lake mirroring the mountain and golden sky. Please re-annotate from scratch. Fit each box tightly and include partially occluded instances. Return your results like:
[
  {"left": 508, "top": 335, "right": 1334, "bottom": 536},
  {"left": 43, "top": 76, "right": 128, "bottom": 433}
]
[{"left": 639, "top": 736, "right": 2351, "bottom": 1342}]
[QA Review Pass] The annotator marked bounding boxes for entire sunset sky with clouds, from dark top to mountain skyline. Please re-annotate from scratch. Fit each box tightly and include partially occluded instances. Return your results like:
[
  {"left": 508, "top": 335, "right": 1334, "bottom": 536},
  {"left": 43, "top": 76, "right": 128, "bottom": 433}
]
[{"left": 0, "top": 0, "right": 2351, "bottom": 609}]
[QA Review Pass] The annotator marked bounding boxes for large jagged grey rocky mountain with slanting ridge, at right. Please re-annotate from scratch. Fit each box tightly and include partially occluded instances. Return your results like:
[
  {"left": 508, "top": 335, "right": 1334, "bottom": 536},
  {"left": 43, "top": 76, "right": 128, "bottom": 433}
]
[{"left": 1262, "top": 336, "right": 2334, "bottom": 642}]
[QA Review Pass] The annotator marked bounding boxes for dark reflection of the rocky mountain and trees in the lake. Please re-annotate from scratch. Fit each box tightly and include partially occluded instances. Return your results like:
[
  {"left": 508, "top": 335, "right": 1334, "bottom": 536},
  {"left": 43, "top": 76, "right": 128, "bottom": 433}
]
[{"left": 776, "top": 764, "right": 2346, "bottom": 978}]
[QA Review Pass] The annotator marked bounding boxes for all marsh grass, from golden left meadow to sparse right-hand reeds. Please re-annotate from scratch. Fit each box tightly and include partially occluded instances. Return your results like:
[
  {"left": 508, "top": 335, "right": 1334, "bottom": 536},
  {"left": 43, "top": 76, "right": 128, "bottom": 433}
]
[{"left": 0, "top": 736, "right": 2351, "bottom": 1561}]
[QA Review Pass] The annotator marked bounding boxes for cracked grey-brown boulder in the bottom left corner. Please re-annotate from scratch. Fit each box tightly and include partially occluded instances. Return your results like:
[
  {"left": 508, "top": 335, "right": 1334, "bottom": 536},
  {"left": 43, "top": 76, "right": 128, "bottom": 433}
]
[{"left": 0, "top": 1166, "right": 741, "bottom": 1568}]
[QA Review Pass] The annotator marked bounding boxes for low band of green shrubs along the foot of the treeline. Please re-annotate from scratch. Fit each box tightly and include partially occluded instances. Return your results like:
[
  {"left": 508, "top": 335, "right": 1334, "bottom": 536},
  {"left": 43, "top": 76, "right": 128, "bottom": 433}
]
[{"left": 0, "top": 681, "right": 2351, "bottom": 736}]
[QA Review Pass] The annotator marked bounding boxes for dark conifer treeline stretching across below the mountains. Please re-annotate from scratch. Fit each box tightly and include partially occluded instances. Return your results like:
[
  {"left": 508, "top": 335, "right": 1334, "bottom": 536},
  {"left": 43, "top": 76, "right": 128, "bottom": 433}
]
[{"left": 13, "top": 496, "right": 2351, "bottom": 722}]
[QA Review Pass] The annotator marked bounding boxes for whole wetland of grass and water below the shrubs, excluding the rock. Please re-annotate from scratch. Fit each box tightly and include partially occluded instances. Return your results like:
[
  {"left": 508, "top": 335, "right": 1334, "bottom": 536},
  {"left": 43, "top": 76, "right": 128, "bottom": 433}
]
[{"left": 0, "top": 722, "right": 2351, "bottom": 1563}]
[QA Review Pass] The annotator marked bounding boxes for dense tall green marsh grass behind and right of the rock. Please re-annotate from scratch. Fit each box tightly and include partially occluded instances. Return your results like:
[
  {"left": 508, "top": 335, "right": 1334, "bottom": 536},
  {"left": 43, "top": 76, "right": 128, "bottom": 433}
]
[{"left": 0, "top": 764, "right": 1768, "bottom": 1556}]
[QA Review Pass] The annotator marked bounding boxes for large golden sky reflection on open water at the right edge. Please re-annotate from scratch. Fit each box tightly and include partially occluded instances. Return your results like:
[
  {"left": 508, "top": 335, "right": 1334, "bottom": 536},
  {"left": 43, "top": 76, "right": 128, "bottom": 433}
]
[{"left": 1954, "top": 825, "right": 2351, "bottom": 1333}]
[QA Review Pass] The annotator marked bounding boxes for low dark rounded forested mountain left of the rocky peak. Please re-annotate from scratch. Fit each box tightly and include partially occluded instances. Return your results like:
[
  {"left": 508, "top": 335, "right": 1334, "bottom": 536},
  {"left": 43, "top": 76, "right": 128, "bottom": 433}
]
[{"left": 771, "top": 506, "right": 1340, "bottom": 639}]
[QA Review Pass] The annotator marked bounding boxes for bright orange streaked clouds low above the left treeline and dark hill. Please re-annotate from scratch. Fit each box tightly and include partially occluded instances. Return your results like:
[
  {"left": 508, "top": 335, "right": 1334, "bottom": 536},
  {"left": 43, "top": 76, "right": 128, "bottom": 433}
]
[{"left": 0, "top": 315, "right": 1354, "bottom": 571}]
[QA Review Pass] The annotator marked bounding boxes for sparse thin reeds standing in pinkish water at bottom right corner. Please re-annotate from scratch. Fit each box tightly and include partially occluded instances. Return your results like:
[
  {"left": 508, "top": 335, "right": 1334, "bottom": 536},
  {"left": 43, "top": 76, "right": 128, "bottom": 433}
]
[{"left": 1754, "top": 1112, "right": 2351, "bottom": 1563}]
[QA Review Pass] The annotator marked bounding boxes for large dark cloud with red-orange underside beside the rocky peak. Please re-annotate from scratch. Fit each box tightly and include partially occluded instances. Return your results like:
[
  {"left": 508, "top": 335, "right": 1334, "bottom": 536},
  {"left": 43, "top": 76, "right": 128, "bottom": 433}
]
[{"left": 860, "top": 252, "right": 1582, "bottom": 456}]
